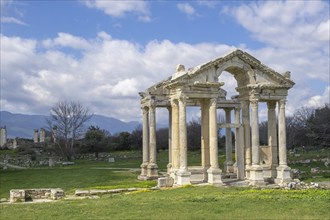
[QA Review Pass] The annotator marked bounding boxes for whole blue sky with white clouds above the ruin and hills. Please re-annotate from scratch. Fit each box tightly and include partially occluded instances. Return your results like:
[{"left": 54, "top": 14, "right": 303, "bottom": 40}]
[{"left": 0, "top": 0, "right": 330, "bottom": 121}]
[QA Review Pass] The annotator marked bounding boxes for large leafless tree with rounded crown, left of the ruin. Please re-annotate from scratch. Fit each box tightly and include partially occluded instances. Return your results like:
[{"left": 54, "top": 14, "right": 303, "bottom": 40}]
[{"left": 47, "top": 101, "right": 92, "bottom": 160}]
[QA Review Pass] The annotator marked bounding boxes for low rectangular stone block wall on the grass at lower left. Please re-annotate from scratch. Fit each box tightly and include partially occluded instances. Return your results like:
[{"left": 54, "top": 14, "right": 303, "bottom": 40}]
[{"left": 10, "top": 188, "right": 64, "bottom": 203}]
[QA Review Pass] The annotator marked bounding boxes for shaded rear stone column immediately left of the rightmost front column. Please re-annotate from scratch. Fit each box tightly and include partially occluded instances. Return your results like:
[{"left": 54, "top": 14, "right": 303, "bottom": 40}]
[{"left": 267, "top": 101, "right": 278, "bottom": 180}]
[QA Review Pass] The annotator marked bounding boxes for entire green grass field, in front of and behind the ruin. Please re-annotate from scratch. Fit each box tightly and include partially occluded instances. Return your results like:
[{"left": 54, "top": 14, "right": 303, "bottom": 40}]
[{"left": 0, "top": 151, "right": 330, "bottom": 219}]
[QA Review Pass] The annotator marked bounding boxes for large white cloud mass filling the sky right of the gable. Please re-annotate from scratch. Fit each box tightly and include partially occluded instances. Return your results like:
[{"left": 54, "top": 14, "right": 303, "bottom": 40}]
[{"left": 226, "top": 1, "right": 330, "bottom": 115}]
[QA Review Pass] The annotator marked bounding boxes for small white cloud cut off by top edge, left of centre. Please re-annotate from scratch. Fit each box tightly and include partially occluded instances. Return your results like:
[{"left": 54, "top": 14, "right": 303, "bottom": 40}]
[{"left": 84, "top": 0, "right": 151, "bottom": 22}]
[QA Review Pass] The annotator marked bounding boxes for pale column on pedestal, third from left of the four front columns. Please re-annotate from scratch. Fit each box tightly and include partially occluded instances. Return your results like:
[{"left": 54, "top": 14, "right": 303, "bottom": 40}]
[{"left": 250, "top": 99, "right": 265, "bottom": 185}]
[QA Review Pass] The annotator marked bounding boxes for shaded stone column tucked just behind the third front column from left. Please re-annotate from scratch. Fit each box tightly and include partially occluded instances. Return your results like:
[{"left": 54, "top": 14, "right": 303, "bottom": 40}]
[{"left": 241, "top": 100, "right": 251, "bottom": 179}]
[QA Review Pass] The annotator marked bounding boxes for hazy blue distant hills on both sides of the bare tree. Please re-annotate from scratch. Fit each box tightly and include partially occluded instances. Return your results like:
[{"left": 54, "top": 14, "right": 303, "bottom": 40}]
[{"left": 0, "top": 111, "right": 139, "bottom": 138}]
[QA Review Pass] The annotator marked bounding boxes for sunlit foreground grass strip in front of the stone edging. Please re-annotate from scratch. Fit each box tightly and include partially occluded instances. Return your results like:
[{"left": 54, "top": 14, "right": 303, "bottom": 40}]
[{"left": 0, "top": 186, "right": 330, "bottom": 220}]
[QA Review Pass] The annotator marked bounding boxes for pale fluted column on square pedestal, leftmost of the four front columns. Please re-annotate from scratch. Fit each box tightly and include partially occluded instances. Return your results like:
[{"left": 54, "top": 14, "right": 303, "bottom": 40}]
[{"left": 177, "top": 96, "right": 191, "bottom": 185}]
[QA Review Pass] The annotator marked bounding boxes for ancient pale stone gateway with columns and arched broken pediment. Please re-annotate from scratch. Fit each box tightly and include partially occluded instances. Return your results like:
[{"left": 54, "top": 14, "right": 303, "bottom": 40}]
[{"left": 138, "top": 50, "right": 294, "bottom": 185}]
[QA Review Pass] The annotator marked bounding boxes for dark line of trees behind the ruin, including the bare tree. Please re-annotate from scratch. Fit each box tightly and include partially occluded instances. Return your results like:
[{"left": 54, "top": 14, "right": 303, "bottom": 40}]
[{"left": 13, "top": 102, "right": 330, "bottom": 160}]
